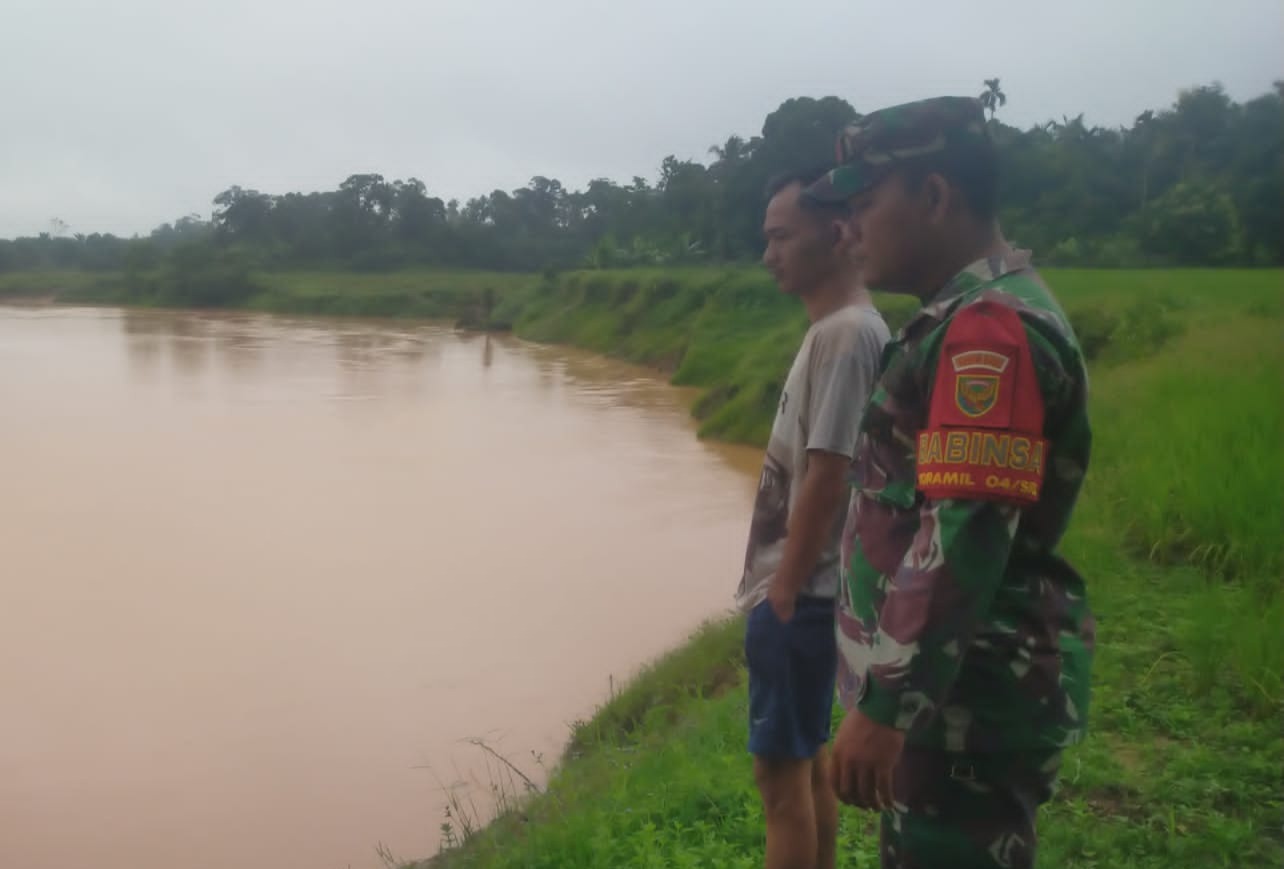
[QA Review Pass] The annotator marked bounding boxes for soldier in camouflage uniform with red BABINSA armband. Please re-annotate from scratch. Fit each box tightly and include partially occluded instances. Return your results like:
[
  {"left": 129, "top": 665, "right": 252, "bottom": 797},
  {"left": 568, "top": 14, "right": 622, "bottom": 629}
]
[{"left": 806, "top": 98, "right": 1094, "bottom": 869}]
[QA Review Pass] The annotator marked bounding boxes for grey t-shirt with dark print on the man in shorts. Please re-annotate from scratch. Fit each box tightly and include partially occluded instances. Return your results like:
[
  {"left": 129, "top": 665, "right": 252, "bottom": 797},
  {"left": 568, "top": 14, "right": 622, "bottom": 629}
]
[{"left": 736, "top": 304, "right": 891, "bottom": 612}]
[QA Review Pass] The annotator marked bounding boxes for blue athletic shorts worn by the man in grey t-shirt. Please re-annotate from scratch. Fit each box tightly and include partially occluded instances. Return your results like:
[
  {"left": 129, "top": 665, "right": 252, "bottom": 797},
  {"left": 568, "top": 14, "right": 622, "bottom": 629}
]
[{"left": 745, "top": 596, "right": 838, "bottom": 760}]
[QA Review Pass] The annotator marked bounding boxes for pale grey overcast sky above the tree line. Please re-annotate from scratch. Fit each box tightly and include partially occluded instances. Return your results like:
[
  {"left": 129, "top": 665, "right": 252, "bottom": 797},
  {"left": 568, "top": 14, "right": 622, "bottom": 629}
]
[{"left": 0, "top": 0, "right": 1284, "bottom": 237}]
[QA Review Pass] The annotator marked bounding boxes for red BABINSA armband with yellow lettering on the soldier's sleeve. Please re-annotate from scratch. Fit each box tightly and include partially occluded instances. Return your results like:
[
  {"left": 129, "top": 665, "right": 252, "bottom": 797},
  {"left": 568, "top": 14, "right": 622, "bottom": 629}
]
[{"left": 917, "top": 300, "right": 1048, "bottom": 504}]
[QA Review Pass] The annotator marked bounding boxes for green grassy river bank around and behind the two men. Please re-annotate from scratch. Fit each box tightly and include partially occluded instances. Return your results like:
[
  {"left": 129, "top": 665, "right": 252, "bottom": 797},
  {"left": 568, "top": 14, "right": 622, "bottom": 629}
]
[{"left": 2, "top": 268, "right": 1284, "bottom": 869}]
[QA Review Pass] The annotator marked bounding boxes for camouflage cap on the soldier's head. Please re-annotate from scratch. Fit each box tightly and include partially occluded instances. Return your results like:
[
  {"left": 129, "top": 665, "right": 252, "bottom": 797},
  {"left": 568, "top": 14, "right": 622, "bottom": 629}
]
[{"left": 804, "top": 96, "right": 993, "bottom": 202}]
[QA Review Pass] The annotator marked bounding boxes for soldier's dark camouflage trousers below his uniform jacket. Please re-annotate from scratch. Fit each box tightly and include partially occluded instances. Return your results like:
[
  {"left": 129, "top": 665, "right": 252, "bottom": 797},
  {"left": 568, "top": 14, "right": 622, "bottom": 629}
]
[{"left": 880, "top": 746, "right": 1061, "bottom": 869}]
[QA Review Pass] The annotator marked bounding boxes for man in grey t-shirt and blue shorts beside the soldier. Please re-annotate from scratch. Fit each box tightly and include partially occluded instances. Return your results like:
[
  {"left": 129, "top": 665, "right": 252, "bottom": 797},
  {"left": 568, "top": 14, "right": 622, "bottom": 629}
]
[{"left": 736, "top": 169, "right": 890, "bottom": 869}]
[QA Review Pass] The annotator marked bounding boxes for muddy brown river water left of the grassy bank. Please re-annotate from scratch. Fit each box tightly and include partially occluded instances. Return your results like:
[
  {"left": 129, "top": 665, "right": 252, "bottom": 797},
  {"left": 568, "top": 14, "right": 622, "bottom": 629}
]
[{"left": 0, "top": 305, "right": 759, "bottom": 869}]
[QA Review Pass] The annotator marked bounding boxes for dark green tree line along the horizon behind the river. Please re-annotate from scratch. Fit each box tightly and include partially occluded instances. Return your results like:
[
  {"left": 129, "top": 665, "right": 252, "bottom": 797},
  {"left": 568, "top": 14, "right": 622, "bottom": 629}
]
[{"left": 0, "top": 78, "right": 1284, "bottom": 281}]
